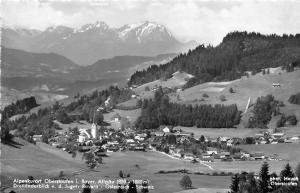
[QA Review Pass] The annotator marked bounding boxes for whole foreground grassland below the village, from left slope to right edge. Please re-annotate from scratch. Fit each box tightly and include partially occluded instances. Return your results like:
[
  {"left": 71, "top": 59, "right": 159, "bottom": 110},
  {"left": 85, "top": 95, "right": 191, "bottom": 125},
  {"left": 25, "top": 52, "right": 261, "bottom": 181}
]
[{"left": 1, "top": 141, "right": 300, "bottom": 193}]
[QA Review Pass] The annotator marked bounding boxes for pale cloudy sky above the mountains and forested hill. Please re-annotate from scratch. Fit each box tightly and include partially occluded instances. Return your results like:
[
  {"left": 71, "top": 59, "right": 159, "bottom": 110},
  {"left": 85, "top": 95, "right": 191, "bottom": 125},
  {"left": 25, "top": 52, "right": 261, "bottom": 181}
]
[{"left": 0, "top": 0, "right": 300, "bottom": 45}]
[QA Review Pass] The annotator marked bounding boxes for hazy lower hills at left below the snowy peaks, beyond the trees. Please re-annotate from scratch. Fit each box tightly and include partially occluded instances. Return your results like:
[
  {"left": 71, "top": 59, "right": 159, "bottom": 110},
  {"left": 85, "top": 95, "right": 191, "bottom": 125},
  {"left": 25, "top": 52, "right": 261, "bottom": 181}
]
[{"left": 1, "top": 46, "right": 176, "bottom": 101}]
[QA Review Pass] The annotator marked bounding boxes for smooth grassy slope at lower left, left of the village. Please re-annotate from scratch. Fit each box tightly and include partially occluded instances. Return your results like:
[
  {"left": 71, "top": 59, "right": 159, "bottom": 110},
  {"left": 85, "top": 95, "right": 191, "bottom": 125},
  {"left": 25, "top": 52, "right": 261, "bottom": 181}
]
[{"left": 0, "top": 138, "right": 84, "bottom": 177}]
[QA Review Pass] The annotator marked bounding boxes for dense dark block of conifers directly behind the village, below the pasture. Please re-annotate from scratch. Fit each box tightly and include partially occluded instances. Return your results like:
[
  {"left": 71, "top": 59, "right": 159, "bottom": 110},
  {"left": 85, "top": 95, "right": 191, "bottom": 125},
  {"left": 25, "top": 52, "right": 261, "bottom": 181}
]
[{"left": 136, "top": 87, "right": 241, "bottom": 129}]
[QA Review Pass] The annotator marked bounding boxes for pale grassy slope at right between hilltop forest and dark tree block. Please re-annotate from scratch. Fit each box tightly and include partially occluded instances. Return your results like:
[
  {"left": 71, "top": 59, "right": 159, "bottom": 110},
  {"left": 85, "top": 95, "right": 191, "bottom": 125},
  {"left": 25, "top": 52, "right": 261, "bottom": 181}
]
[{"left": 172, "top": 71, "right": 300, "bottom": 114}]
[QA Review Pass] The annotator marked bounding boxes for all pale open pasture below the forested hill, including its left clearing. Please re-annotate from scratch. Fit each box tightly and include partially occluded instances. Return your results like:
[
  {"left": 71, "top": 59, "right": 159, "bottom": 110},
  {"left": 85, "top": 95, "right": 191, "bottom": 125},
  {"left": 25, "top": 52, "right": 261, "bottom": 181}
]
[{"left": 126, "top": 67, "right": 300, "bottom": 128}]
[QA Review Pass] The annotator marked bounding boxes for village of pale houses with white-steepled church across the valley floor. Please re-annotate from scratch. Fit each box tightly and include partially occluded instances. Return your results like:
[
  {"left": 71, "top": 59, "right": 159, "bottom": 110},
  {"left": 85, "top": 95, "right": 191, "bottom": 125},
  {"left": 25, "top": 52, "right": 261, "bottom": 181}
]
[{"left": 33, "top": 113, "right": 300, "bottom": 167}]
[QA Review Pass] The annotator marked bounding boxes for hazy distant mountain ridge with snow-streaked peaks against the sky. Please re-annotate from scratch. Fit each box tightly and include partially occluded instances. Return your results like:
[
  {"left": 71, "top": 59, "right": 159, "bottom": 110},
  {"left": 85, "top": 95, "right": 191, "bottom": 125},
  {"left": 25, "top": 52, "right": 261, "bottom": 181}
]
[{"left": 2, "top": 21, "right": 196, "bottom": 65}]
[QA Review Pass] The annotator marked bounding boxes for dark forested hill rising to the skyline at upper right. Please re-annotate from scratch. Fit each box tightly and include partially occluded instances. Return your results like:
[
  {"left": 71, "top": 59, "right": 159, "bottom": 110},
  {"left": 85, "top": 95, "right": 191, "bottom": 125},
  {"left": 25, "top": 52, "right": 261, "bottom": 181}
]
[{"left": 128, "top": 32, "right": 300, "bottom": 87}]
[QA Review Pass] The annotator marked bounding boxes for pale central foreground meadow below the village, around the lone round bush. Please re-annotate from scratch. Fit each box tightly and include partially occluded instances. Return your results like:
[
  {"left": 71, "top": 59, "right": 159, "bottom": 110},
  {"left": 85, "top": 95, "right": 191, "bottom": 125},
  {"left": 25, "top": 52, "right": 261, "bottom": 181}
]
[{"left": 72, "top": 152, "right": 230, "bottom": 193}]
